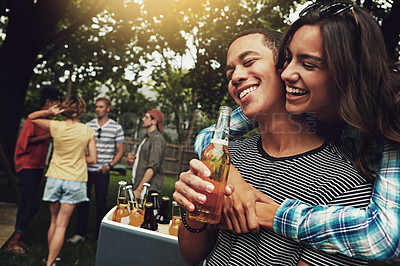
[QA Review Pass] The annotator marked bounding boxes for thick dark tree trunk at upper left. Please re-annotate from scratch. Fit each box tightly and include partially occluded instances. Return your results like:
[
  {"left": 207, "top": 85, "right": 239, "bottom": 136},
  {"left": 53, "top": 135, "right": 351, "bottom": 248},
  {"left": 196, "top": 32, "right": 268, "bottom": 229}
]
[{"left": 0, "top": 0, "right": 70, "bottom": 168}]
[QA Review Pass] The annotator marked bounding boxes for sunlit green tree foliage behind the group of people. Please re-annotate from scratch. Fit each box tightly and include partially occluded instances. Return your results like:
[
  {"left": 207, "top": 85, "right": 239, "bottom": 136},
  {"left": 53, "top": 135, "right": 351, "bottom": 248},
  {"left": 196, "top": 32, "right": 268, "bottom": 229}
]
[{"left": 0, "top": 0, "right": 398, "bottom": 143}]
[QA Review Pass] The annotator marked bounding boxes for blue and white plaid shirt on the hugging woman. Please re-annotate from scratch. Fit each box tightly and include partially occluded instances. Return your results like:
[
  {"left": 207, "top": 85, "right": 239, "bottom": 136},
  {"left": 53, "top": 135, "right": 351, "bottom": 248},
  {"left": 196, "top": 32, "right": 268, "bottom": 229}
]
[{"left": 195, "top": 108, "right": 400, "bottom": 260}]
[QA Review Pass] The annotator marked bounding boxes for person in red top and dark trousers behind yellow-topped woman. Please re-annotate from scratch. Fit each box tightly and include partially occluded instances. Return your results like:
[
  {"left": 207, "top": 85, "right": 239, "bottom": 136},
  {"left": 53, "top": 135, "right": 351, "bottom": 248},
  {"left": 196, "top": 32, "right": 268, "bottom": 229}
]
[{"left": 7, "top": 87, "right": 61, "bottom": 254}]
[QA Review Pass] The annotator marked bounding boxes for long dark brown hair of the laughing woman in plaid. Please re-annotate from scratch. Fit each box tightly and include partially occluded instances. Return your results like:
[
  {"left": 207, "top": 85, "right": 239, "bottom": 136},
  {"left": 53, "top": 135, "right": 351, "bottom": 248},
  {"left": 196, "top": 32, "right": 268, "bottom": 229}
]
[{"left": 276, "top": 6, "right": 400, "bottom": 178}]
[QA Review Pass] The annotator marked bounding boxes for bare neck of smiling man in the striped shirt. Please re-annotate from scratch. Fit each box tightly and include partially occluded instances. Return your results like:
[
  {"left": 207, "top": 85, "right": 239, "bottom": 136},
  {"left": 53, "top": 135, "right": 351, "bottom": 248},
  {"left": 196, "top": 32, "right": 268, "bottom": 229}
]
[{"left": 258, "top": 114, "right": 325, "bottom": 157}]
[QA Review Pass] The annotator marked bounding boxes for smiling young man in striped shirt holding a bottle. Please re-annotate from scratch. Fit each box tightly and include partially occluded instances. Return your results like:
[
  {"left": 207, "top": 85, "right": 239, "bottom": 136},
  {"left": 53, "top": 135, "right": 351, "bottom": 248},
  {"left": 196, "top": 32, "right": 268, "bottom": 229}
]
[{"left": 174, "top": 29, "right": 371, "bottom": 265}]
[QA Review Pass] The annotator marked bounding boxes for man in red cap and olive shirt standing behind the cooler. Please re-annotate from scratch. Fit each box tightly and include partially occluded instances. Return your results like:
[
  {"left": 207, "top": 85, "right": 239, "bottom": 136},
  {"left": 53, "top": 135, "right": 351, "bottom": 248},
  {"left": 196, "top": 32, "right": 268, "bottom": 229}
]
[{"left": 127, "top": 109, "right": 165, "bottom": 198}]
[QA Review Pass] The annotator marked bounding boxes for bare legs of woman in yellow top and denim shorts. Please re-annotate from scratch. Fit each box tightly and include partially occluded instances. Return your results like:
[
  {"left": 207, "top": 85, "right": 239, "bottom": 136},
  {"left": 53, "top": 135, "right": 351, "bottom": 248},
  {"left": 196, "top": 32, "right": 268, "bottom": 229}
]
[{"left": 47, "top": 203, "right": 75, "bottom": 266}]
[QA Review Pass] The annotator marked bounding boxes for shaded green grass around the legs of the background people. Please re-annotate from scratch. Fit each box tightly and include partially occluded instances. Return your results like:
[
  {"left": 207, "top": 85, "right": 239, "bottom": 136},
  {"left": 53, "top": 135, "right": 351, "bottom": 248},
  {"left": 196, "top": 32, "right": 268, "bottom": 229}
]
[{"left": 0, "top": 171, "right": 177, "bottom": 266}]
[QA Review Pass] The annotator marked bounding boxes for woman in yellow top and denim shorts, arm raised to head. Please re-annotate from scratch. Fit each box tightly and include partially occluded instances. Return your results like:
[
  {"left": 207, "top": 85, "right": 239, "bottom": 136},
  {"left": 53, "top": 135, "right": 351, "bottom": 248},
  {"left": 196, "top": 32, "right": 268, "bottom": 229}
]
[{"left": 28, "top": 96, "right": 97, "bottom": 266}]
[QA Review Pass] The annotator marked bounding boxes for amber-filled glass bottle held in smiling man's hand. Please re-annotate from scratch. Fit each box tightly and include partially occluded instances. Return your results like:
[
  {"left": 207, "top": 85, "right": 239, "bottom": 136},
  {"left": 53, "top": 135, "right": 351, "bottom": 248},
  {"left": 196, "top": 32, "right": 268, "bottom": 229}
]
[{"left": 189, "top": 106, "right": 232, "bottom": 224}]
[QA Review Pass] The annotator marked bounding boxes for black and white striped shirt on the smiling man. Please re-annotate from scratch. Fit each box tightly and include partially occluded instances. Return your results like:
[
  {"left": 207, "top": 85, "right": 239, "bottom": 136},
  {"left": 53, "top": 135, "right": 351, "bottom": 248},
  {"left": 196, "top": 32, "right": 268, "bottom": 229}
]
[{"left": 208, "top": 135, "right": 372, "bottom": 265}]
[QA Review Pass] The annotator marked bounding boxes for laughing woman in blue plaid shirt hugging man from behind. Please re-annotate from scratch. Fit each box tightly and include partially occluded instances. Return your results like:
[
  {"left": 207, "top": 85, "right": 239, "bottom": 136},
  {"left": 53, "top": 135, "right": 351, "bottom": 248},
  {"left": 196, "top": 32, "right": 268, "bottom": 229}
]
[{"left": 179, "top": 3, "right": 400, "bottom": 260}]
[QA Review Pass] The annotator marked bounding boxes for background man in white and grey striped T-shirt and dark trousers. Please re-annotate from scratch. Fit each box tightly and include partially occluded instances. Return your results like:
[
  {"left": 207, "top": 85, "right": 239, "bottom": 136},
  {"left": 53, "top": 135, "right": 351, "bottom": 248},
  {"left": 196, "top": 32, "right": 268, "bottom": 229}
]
[{"left": 67, "top": 98, "right": 125, "bottom": 244}]
